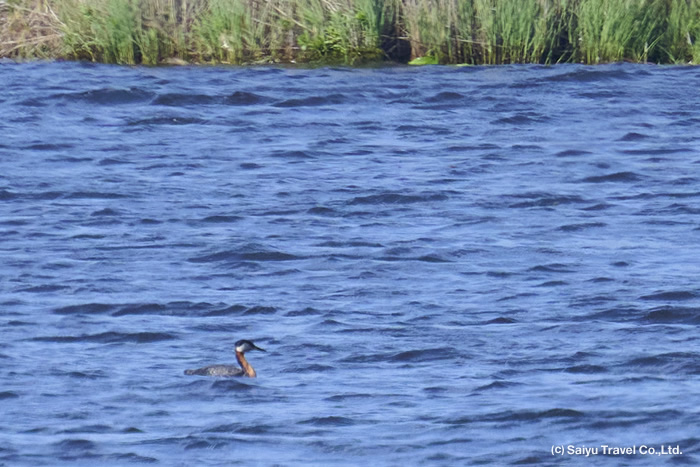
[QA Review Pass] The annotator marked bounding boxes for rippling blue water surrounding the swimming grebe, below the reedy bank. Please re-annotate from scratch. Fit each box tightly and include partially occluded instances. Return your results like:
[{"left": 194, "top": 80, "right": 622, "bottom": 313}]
[{"left": 0, "top": 63, "right": 700, "bottom": 466}]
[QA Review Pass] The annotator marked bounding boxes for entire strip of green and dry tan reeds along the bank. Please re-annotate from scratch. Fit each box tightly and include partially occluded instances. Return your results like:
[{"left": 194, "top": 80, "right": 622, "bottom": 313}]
[{"left": 0, "top": 0, "right": 700, "bottom": 65}]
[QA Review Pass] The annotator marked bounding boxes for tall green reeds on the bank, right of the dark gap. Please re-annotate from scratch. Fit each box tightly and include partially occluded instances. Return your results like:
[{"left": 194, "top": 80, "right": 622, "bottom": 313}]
[{"left": 402, "top": 0, "right": 700, "bottom": 64}]
